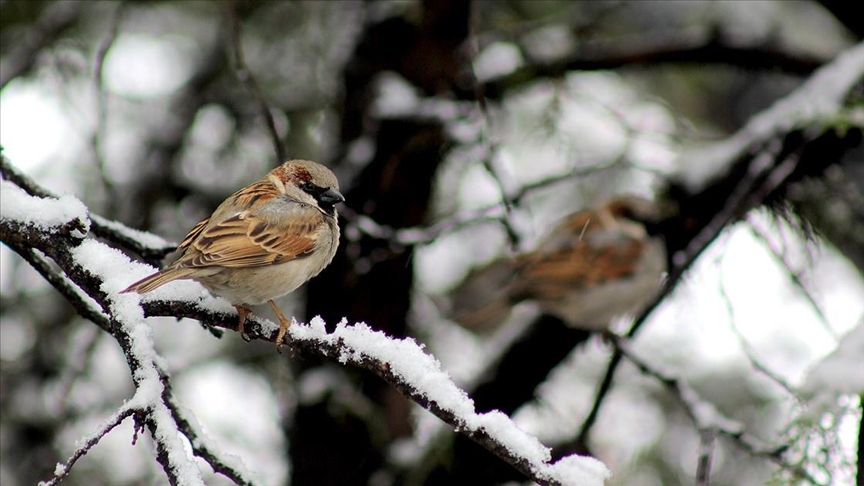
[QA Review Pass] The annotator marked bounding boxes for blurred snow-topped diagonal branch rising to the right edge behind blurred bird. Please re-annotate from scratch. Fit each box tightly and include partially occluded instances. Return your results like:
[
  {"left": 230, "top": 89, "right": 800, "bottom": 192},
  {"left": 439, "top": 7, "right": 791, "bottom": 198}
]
[{"left": 560, "top": 44, "right": 864, "bottom": 451}]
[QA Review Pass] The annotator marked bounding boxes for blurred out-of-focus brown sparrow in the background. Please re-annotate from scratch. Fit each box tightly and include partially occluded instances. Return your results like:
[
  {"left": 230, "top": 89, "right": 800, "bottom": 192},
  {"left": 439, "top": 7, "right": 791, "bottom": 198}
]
[{"left": 453, "top": 196, "right": 666, "bottom": 332}]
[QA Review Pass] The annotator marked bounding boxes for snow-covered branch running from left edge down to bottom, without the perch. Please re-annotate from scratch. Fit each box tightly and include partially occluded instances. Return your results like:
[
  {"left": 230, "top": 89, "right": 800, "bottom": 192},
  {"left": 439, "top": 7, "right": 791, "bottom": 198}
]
[{"left": 0, "top": 163, "right": 252, "bottom": 485}]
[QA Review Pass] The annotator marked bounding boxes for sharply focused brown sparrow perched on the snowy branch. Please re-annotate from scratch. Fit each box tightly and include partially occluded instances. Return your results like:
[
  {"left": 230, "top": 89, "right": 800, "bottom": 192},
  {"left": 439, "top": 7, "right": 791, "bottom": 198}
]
[{"left": 121, "top": 160, "right": 345, "bottom": 346}]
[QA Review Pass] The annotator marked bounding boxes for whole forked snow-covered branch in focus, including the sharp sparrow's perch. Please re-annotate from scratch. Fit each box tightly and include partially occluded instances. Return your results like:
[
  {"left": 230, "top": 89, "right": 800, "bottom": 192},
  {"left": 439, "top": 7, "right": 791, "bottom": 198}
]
[{"left": 0, "top": 160, "right": 609, "bottom": 486}]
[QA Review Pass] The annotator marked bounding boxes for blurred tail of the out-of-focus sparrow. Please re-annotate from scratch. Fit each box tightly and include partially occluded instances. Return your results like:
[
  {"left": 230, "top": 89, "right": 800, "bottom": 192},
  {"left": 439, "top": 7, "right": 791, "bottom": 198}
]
[{"left": 452, "top": 259, "right": 515, "bottom": 334}]
